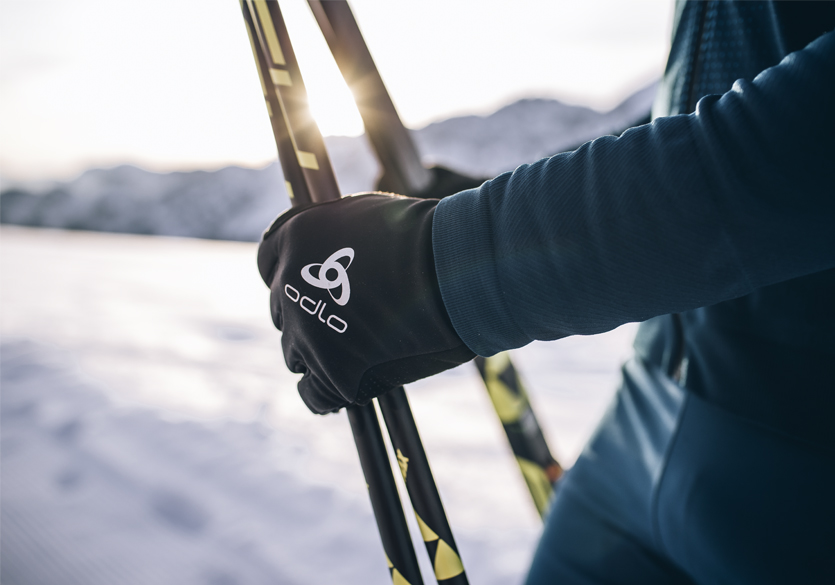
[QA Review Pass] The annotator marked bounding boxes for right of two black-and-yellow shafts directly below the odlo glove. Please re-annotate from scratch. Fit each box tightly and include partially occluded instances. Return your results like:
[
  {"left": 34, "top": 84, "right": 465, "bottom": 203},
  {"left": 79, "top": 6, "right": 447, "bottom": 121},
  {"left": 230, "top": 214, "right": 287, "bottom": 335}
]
[{"left": 379, "top": 386, "right": 468, "bottom": 585}]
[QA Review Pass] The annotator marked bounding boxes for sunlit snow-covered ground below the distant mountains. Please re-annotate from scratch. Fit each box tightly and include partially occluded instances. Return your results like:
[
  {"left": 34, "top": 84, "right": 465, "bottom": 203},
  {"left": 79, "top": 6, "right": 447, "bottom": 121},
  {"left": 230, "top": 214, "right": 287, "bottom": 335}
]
[{"left": 0, "top": 226, "right": 635, "bottom": 585}]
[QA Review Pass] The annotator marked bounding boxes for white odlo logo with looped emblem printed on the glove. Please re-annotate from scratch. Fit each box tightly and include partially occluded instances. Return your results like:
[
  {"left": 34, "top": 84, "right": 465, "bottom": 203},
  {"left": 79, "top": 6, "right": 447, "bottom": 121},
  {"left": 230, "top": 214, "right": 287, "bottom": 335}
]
[{"left": 284, "top": 248, "right": 354, "bottom": 333}]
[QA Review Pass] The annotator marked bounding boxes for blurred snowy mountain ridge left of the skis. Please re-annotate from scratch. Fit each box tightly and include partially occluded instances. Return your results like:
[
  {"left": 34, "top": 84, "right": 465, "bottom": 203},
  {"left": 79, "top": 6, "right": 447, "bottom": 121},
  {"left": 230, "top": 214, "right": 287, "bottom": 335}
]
[{"left": 0, "top": 164, "right": 289, "bottom": 241}]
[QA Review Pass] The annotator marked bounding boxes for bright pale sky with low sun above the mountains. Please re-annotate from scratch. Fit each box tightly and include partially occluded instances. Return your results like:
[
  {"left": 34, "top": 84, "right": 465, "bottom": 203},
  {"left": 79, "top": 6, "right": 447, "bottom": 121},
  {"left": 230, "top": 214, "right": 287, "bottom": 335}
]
[{"left": 0, "top": 0, "right": 672, "bottom": 179}]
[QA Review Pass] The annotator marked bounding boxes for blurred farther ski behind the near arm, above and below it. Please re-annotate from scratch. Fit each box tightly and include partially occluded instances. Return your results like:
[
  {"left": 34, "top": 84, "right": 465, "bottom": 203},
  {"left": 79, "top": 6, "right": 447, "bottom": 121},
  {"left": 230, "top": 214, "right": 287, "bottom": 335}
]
[{"left": 308, "top": 0, "right": 562, "bottom": 516}]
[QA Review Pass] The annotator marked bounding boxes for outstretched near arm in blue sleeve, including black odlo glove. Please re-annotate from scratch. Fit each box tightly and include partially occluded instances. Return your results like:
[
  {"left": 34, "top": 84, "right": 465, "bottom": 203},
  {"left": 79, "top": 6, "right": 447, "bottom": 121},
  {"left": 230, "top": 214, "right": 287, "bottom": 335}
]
[{"left": 258, "top": 33, "right": 835, "bottom": 413}]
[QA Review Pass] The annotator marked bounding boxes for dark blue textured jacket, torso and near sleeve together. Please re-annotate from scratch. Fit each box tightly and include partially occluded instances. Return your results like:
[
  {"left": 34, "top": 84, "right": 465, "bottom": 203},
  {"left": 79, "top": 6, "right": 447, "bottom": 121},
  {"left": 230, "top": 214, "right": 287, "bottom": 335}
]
[{"left": 433, "top": 2, "right": 835, "bottom": 448}]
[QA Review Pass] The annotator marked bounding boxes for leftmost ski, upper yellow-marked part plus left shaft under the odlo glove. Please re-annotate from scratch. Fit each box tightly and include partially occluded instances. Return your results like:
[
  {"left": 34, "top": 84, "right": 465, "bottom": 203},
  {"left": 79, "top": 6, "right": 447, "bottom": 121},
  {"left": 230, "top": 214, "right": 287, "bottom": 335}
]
[{"left": 240, "top": 0, "right": 423, "bottom": 585}]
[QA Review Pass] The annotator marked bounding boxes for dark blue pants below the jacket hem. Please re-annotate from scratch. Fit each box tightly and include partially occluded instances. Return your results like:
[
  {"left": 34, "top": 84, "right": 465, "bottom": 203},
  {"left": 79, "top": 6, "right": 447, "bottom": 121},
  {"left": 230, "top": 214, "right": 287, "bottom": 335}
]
[{"left": 527, "top": 360, "right": 835, "bottom": 585}]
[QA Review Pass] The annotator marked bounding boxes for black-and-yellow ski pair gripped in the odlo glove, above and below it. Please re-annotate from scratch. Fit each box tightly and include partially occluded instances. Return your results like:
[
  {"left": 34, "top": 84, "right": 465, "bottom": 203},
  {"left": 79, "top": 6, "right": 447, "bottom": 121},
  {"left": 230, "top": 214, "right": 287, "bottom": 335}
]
[{"left": 241, "top": 0, "right": 467, "bottom": 585}]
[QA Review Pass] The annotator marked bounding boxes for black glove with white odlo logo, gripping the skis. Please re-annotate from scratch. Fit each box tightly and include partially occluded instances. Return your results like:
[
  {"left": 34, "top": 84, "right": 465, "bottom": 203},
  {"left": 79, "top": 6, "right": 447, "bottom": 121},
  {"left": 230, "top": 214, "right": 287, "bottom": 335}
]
[{"left": 258, "top": 193, "right": 475, "bottom": 414}]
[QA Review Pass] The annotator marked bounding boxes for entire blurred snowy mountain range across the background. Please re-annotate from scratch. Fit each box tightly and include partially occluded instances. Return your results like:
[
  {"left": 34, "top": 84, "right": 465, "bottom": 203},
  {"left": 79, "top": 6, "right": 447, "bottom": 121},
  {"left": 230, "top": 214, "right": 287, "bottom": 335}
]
[{"left": 0, "top": 84, "right": 656, "bottom": 241}]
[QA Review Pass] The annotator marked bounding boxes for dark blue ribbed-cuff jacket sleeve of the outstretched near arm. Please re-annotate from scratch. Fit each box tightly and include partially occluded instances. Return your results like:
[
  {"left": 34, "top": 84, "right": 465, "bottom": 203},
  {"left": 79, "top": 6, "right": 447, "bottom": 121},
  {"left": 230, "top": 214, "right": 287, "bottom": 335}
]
[{"left": 432, "top": 32, "right": 835, "bottom": 355}]
